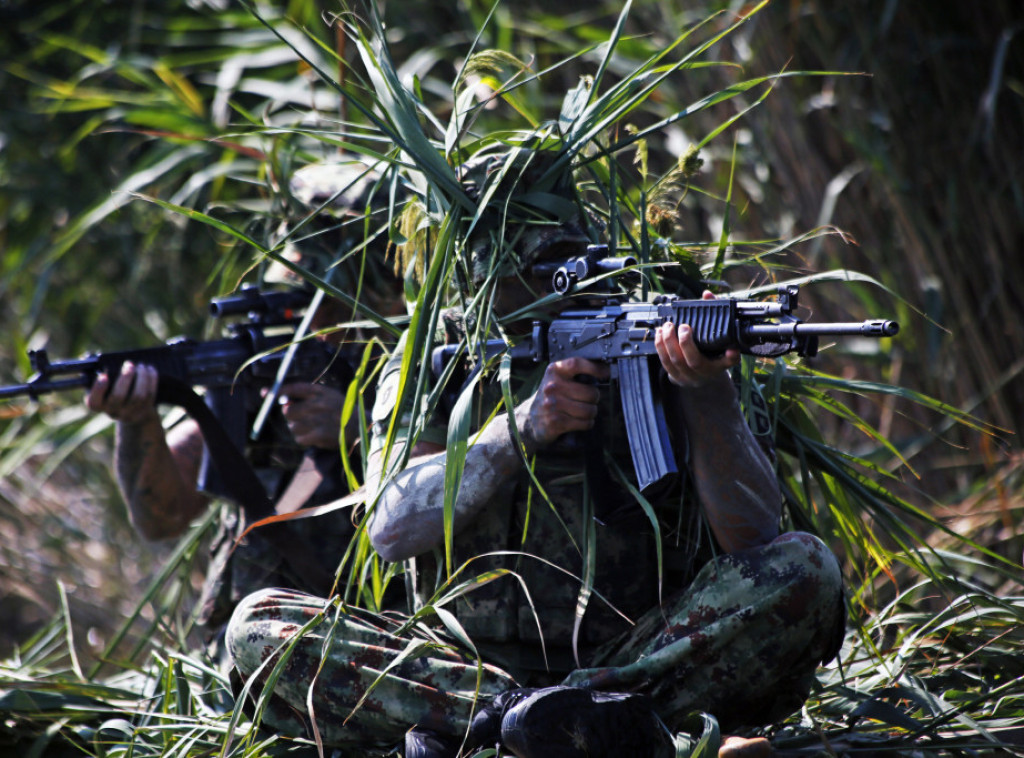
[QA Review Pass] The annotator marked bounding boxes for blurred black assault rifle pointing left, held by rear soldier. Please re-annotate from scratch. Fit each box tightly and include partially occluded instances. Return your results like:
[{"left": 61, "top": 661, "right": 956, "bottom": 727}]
[{"left": 0, "top": 286, "right": 350, "bottom": 520}]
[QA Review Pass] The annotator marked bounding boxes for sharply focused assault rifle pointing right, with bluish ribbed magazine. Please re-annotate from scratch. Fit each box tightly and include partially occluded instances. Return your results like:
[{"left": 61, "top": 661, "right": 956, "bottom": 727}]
[{"left": 431, "top": 285, "right": 899, "bottom": 490}]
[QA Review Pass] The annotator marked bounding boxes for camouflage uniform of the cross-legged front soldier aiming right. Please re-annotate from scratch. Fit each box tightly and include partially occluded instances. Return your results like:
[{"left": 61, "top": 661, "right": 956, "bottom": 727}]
[{"left": 227, "top": 325, "right": 844, "bottom": 747}]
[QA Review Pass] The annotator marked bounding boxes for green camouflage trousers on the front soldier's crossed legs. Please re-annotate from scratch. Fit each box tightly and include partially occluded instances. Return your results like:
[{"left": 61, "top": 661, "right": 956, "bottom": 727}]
[{"left": 227, "top": 533, "right": 845, "bottom": 748}]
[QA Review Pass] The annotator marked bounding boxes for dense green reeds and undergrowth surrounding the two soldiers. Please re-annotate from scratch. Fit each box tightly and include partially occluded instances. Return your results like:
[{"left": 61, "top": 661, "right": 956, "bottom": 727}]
[{"left": 0, "top": 0, "right": 1024, "bottom": 755}]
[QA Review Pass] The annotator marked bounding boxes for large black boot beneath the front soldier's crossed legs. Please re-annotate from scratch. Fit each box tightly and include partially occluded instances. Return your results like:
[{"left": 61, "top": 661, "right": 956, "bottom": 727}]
[{"left": 502, "top": 686, "right": 675, "bottom": 758}]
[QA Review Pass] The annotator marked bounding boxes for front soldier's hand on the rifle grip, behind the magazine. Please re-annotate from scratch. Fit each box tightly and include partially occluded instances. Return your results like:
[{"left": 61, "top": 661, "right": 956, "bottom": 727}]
[{"left": 516, "top": 357, "right": 610, "bottom": 450}]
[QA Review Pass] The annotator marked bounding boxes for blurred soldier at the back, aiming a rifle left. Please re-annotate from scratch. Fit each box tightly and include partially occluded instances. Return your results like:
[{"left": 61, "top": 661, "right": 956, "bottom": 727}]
[{"left": 86, "top": 158, "right": 404, "bottom": 658}]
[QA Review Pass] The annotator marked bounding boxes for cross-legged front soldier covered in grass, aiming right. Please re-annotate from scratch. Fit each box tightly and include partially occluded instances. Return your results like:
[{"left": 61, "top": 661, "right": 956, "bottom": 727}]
[{"left": 227, "top": 149, "right": 844, "bottom": 758}]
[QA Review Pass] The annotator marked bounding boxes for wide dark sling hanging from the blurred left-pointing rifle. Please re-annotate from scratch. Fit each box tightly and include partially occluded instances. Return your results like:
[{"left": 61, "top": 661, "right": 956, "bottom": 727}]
[{"left": 157, "top": 374, "right": 334, "bottom": 595}]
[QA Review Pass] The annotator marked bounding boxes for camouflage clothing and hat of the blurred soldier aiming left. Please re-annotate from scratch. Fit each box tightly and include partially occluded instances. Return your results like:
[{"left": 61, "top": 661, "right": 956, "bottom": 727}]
[{"left": 199, "top": 157, "right": 403, "bottom": 654}]
